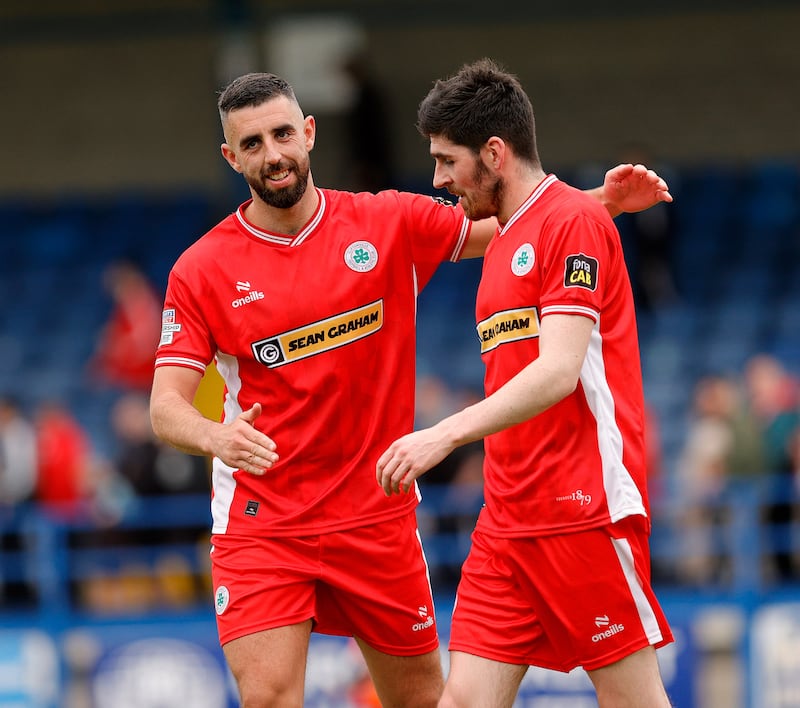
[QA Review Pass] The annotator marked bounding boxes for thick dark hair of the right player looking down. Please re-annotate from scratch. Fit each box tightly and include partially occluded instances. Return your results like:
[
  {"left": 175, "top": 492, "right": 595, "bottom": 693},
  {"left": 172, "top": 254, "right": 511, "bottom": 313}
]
[{"left": 417, "top": 59, "right": 539, "bottom": 164}]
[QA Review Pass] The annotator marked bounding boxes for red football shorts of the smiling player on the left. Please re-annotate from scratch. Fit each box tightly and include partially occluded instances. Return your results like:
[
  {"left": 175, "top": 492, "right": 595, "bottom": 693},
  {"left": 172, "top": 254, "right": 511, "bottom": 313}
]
[{"left": 211, "top": 512, "right": 439, "bottom": 656}]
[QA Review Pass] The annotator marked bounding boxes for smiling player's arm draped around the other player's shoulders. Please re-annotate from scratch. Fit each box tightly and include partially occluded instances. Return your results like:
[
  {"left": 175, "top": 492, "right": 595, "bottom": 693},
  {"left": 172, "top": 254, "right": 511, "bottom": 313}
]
[{"left": 462, "top": 164, "right": 672, "bottom": 258}]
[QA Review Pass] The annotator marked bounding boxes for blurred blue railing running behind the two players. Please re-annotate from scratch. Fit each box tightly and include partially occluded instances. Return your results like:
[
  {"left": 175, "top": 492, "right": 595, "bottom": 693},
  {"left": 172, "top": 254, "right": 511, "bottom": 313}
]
[{"left": 0, "top": 477, "right": 800, "bottom": 614}]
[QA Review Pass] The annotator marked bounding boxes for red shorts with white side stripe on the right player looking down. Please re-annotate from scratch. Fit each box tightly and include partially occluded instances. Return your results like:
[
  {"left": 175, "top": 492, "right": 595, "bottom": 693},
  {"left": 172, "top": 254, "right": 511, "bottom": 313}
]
[{"left": 450, "top": 516, "right": 672, "bottom": 672}]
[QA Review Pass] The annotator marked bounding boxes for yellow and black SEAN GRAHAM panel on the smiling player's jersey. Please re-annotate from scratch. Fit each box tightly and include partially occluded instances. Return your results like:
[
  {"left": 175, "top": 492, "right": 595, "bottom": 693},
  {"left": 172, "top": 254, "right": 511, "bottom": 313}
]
[{"left": 250, "top": 300, "right": 383, "bottom": 369}]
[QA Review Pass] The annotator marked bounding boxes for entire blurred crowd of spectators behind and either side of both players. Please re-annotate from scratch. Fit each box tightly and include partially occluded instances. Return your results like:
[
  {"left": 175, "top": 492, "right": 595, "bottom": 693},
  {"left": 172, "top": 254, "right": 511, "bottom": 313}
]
[{"left": 0, "top": 261, "right": 800, "bottom": 612}]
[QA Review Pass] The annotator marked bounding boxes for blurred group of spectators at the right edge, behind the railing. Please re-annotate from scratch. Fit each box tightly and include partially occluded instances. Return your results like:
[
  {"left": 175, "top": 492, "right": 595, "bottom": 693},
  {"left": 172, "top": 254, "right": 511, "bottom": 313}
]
[{"left": 673, "top": 354, "right": 800, "bottom": 585}]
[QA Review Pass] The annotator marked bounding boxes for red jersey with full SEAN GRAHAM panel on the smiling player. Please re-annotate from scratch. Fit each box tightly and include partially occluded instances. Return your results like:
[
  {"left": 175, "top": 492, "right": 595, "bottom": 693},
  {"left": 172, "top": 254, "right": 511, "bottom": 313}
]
[{"left": 156, "top": 190, "right": 470, "bottom": 536}]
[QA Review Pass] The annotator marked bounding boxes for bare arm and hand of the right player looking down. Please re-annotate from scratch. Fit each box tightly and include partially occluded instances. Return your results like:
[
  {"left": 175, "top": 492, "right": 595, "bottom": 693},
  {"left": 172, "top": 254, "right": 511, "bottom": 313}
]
[{"left": 376, "top": 315, "right": 594, "bottom": 495}]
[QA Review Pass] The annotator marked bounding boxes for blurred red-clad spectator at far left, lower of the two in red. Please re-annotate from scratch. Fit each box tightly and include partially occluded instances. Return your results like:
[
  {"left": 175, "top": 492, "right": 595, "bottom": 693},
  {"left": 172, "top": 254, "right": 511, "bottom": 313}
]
[{"left": 35, "top": 401, "right": 92, "bottom": 515}]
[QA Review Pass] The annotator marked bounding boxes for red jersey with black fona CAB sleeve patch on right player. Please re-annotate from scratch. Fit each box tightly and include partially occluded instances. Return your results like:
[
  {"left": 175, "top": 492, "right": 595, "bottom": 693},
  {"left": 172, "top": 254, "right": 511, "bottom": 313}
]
[{"left": 476, "top": 175, "right": 647, "bottom": 536}]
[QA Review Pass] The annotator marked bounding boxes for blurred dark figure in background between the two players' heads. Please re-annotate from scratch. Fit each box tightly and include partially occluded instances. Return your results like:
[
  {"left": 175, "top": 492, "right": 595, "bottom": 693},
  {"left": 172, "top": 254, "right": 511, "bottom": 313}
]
[{"left": 343, "top": 53, "right": 394, "bottom": 192}]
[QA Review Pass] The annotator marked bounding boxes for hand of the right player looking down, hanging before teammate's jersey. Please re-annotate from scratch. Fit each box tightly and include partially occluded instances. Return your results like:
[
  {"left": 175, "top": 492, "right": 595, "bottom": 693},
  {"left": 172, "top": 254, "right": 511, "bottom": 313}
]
[{"left": 375, "top": 426, "right": 453, "bottom": 497}]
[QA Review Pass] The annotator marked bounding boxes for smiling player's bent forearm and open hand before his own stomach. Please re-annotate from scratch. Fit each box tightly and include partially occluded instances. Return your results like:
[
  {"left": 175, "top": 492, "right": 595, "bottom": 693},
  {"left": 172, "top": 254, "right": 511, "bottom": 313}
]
[{"left": 150, "top": 366, "right": 278, "bottom": 474}]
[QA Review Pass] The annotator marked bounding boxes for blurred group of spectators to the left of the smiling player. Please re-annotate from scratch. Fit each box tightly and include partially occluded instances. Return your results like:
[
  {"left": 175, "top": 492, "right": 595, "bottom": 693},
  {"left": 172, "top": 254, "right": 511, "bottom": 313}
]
[{"left": 0, "top": 261, "right": 210, "bottom": 611}]
